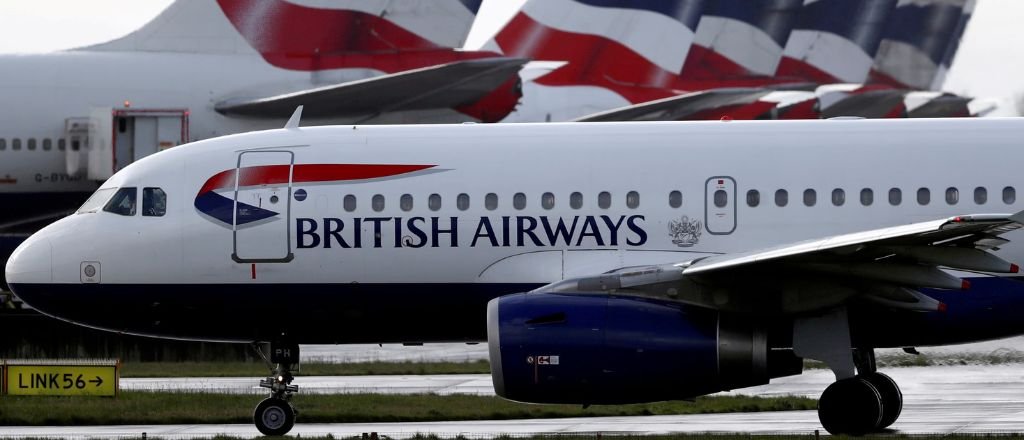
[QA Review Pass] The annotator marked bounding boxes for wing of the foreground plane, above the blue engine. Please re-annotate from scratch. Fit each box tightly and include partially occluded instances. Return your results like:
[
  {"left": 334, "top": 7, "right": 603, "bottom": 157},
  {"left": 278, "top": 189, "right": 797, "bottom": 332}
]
[{"left": 535, "top": 212, "right": 1024, "bottom": 313}]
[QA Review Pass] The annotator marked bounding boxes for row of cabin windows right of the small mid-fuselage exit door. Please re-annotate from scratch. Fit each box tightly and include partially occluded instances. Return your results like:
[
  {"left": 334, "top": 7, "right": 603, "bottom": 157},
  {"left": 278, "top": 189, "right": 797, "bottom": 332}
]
[{"left": 746, "top": 186, "right": 1017, "bottom": 208}]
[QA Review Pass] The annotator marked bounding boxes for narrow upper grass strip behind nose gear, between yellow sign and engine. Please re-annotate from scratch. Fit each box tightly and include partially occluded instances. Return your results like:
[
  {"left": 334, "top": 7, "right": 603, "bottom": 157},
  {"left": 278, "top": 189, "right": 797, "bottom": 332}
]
[{"left": 121, "top": 360, "right": 490, "bottom": 378}]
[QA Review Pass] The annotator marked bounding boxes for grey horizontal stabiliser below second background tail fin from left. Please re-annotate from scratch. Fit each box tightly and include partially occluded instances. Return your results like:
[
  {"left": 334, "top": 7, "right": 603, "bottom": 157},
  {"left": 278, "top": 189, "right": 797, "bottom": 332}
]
[{"left": 575, "top": 88, "right": 773, "bottom": 122}]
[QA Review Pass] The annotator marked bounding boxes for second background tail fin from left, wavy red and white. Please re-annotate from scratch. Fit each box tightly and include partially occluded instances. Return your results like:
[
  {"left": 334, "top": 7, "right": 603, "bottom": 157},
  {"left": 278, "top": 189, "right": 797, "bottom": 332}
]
[{"left": 484, "top": 0, "right": 705, "bottom": 96}]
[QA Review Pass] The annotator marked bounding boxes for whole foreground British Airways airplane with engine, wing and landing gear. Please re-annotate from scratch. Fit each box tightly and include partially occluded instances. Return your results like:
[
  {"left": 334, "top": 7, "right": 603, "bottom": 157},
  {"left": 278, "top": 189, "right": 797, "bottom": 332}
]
[{"left": 6, "top": 115, "right": 1024, "bottom": 434}]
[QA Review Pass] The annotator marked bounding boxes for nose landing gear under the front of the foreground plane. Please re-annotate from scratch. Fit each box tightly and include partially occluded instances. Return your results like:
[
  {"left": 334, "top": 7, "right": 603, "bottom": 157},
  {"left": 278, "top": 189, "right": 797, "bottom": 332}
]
[{"left": 253, "top": 336, "right": 299, "bottom": 436}]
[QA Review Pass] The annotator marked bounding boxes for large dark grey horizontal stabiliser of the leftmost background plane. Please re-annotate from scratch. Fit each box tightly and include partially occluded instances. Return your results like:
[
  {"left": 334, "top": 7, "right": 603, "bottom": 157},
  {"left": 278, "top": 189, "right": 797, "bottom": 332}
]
[{"left": 214, "top": 57, "right": 527, "bottom": 119}]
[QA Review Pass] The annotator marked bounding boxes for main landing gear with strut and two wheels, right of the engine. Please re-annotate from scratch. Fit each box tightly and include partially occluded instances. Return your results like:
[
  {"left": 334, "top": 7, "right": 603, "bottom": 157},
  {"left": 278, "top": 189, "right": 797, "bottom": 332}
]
[{"left": 793, "top": 309, "right": 903, "bottom": 436}]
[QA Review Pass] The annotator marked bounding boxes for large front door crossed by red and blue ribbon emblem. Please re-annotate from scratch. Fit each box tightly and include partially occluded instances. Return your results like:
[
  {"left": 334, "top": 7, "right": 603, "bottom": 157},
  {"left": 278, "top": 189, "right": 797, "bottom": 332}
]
[{"left": 231, "top": 150, "right": 295, "bottom": 263}]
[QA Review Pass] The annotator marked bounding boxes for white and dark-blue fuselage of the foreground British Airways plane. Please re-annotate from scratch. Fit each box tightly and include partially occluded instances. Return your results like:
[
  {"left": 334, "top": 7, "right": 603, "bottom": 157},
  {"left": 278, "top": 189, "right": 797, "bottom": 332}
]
[{"left": 7, "top": 120, "right": 1024, "bottom": 347}]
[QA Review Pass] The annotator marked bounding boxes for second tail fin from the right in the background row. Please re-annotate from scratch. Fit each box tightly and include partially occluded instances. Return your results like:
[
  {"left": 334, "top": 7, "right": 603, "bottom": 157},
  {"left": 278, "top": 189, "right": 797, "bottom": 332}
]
[{"left": 776, "top": 0, "right": 896, "bottom": 84}]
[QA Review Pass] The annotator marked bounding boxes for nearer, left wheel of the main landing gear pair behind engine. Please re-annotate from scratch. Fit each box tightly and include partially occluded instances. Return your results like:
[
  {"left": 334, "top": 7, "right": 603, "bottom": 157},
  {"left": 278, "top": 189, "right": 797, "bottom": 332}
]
[{"left": 818, "top": 378, "right": 884, "bottom": 436}]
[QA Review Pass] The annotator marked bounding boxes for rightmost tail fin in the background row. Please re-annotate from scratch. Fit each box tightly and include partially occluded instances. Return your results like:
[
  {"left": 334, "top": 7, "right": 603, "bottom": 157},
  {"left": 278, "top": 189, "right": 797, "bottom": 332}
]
[{"left": 871, "top": 0, "right": 974, "bottom": 90}]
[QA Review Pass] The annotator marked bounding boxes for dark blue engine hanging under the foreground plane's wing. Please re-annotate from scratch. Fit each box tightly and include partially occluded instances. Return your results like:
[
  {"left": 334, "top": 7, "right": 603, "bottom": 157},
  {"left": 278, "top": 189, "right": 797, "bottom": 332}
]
[{"left": 487, "top": 293, "right": 801, "bottom": 404}]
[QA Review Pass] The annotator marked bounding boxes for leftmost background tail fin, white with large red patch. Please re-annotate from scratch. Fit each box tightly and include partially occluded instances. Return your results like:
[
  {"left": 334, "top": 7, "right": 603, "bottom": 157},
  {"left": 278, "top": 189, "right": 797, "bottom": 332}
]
[{"left": 83, "top": 0, "right": 480, "bottom": 70}]
